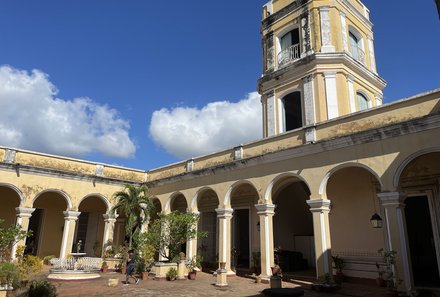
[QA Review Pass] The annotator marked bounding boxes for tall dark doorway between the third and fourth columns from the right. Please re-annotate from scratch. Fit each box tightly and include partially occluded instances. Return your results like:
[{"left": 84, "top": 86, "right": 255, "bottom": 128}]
[{"left": 233, "top": 209, "right": 249, "bottom": 268}]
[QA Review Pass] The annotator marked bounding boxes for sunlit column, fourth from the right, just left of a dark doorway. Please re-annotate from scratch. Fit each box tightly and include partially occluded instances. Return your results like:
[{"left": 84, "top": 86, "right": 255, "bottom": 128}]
[{"left": 215, "top": 208, "right": 235, "bottom": 275}]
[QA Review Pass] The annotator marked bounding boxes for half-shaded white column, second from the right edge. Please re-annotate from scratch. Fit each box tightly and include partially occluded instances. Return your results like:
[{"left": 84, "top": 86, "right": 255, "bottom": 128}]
[{"left": 306, "top": 199, "right": 332, "bottom": 277}]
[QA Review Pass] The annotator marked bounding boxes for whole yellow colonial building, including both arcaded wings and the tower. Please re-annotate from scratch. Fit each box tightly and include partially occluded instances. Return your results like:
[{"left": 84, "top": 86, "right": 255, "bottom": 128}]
[{"left": 0, "top": 0, "right": 440, "bottom": 292}]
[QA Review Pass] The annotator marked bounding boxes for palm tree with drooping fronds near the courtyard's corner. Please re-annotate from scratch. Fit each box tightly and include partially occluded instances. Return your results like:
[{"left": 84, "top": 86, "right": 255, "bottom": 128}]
[{"left": 112, "top": 185, "right": 154, "bottom": 248}]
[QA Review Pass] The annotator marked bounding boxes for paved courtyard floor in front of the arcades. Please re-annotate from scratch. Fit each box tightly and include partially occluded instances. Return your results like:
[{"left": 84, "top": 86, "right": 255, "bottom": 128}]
[{"left": 49, "top": 272, "right": 392, "bottom": 297}]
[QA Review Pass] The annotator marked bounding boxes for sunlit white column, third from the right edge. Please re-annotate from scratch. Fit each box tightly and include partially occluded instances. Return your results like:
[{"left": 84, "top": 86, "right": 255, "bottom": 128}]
[{"left": 255, "top": 204, "right": 275, "bottom": 278}]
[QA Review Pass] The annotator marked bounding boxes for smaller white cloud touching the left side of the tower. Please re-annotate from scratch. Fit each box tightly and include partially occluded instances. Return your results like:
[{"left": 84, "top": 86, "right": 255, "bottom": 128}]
[{"left": 150, "top": 92, "right": 262, "bottom": 159}]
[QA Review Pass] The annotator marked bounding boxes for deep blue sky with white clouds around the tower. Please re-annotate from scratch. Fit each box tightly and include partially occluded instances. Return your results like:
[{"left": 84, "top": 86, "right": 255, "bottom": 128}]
[{"left": 0, "top": 0, "right": 440, "bottom": 170}]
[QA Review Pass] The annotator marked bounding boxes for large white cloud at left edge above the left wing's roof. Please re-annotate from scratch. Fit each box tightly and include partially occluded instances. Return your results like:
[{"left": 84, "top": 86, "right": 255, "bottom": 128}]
[{"left": 0, "top": 66, "right": 136, "bottom": 158}]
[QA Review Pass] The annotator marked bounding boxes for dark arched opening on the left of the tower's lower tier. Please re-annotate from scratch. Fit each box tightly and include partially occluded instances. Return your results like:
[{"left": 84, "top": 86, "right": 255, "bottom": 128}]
[{"left": 282, "top": 92, "right": 302, "bottom": 132}]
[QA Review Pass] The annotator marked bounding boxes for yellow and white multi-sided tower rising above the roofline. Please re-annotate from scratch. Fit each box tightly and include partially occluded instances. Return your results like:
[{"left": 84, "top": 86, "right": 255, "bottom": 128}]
[{"left": 258, "top": 0, "right": 386, "bottom": 142}]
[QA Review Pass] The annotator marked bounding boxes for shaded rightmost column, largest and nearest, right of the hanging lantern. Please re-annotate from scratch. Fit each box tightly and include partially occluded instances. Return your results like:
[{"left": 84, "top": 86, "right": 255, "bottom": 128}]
[{"left": 377, "top": 192, "right": 414, "bottom": 293}]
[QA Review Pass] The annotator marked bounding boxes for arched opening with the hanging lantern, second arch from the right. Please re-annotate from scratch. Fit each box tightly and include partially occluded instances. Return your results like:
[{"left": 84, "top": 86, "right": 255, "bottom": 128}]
[{"left": 321, "top": 162, "right": 385, "bottom": 275}]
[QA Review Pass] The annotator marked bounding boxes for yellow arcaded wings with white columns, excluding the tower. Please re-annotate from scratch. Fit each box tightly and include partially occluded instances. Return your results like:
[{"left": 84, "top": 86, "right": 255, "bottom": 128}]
[{"left": 0, "top": 90, "right": 440, "bottom": 290}]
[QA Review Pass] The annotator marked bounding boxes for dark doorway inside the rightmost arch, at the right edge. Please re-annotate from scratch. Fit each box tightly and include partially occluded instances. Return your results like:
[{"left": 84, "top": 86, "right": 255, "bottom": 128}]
[{"left": 405, "top": 196, "right": 440, "bottom": 287}]
